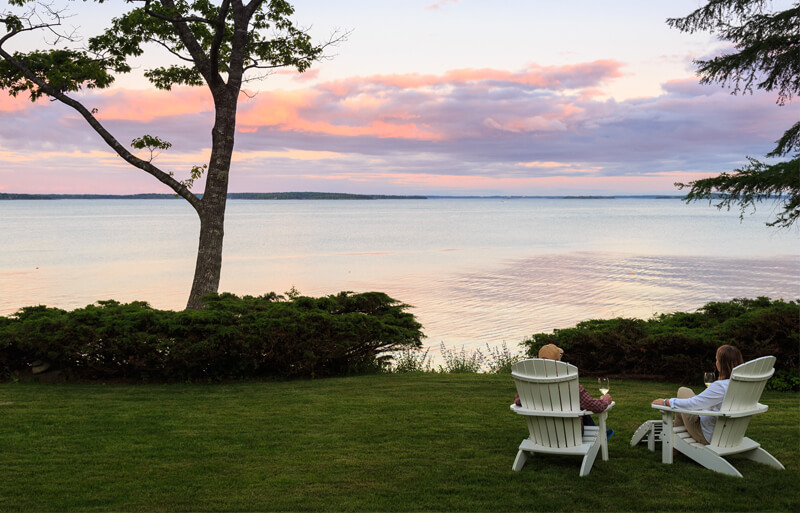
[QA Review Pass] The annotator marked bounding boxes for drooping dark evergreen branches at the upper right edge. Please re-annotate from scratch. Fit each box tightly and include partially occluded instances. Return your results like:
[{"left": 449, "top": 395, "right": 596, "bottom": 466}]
[{"left": 667, "top": 0, "right": 800, "bottom": 228}]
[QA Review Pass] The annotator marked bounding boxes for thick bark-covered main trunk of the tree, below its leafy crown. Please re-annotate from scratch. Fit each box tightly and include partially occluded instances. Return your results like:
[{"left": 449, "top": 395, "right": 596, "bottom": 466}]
[{"left": 186, "top": 89, "right": 238, "bottom": 310}]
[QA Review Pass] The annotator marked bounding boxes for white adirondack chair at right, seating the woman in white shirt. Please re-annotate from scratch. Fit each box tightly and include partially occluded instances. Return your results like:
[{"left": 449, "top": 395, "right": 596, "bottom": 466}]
[{"left": 648, "top": 356, "right": 784, "bottom": 477}]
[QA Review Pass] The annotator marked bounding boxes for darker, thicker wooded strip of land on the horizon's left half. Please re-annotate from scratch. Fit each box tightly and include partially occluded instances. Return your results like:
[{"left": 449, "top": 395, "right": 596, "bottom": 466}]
[{"left": 0, "top": 192, "right": 428, "bottom": 200}]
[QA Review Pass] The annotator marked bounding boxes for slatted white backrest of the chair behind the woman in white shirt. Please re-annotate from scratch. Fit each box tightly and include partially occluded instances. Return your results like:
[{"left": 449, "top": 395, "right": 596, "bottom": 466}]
[{"left": 711, "top": 356, "right": 775, "bottom": 447}]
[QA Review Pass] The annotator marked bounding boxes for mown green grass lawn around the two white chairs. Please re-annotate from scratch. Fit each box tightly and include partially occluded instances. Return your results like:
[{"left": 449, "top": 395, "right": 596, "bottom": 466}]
[{"left": 0, "top": 374, "right": 800, "bottom": 512}]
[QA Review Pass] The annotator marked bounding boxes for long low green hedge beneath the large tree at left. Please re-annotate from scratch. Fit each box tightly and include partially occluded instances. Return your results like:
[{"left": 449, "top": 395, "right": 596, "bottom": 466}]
[{"left": 0, "top": 292, "right": 423, "bottom": 381}]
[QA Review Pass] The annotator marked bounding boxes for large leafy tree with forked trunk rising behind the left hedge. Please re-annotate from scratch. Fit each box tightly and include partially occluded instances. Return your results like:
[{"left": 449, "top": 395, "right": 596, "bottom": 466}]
[{"left": 0, "top": 0, "right": 343, "bottom": 309}]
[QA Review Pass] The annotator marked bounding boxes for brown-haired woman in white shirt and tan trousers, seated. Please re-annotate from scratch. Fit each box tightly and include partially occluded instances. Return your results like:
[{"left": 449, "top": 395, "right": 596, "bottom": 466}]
[{"left": 653, "top": 345, "right": 744, "bottom": 445}]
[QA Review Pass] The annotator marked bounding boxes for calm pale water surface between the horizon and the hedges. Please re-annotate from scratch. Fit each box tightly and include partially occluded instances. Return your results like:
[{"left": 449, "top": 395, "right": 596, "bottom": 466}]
[{"left": 0, "top": 199, "right": 800, "bottom": 353}]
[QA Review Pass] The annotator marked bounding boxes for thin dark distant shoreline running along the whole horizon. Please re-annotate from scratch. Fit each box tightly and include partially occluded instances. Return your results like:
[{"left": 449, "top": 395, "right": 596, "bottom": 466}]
[{"left": 0, "top": 192, "right": 683, "bottom": 201}]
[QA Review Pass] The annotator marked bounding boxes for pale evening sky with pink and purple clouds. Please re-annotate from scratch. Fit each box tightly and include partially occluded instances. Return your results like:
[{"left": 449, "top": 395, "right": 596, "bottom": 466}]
[{"left": 0, "top": 0, "right": 800, "bottom": 196}]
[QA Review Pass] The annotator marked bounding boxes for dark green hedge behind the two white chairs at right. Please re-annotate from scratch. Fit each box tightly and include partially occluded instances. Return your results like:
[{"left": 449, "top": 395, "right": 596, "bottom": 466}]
[{"left": 522, "top": 297, "right": 800, "bottom": 390}]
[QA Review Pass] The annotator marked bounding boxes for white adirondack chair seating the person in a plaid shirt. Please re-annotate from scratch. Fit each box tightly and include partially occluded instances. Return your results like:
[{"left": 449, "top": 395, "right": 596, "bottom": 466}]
[{"left": 511, "top": 358, "right": 614, "bottom": 476}]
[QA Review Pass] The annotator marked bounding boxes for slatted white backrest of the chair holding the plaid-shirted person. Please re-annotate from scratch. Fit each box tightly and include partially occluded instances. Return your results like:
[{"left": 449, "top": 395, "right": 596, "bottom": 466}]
[{"left": 511, "top": 358, "right": 583, "bottom": 448}]
